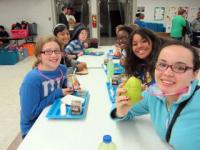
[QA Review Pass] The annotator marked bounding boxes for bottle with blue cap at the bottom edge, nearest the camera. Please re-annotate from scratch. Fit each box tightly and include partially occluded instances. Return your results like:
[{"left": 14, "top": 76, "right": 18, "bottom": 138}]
[{"left": 98, "top": 135, "right": 117, "bottom": 150}]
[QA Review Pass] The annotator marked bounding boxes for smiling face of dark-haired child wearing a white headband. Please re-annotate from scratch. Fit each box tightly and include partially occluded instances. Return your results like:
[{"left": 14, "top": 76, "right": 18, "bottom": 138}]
[{"left": 56, "top": 29, "right": 70, "bottom": 46}]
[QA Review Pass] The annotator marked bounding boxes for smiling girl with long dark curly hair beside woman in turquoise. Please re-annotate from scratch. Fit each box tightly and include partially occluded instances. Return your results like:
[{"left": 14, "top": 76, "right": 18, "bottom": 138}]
[{"left": 125, "top": 28, "right": 165, "bottom": 88}]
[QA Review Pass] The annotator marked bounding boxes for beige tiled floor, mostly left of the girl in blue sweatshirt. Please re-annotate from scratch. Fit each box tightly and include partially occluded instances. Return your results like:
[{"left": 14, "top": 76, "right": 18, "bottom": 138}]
[{"left": 0, "top": 43, "right": 200, "bottom": 150}]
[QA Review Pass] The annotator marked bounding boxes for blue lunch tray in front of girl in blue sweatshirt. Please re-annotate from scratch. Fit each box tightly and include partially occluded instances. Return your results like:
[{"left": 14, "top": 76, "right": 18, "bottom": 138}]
[{"left": 46, "top": 91, "right": 90, "bottom": 119}]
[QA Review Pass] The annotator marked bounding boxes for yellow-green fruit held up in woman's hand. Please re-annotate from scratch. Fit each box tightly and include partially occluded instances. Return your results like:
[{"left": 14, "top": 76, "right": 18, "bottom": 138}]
[{"left": 123, "top": 77, "right": 142, "bottom": 105}]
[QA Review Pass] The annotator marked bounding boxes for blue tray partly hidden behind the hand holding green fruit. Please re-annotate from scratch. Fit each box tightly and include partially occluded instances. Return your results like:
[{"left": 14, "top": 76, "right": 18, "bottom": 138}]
[{"left": 106, "top": 82, "right": 117, "bottom": 103}]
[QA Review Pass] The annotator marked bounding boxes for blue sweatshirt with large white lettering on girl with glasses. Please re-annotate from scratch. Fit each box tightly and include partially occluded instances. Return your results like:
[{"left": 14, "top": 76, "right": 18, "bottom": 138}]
[{"left": 19, "top": 65, "right": 67, "bottom": 136}]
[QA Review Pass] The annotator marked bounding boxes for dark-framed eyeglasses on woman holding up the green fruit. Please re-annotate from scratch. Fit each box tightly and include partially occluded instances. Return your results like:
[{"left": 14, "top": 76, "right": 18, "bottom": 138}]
[{"left": 156, "top": 62, "right": 193, "bottom": 73}]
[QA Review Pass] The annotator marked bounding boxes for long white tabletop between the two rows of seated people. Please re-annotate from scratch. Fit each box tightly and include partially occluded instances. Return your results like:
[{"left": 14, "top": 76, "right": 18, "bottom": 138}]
[{"left": 18, "top": 48, "right": 170, "bottom": 150}]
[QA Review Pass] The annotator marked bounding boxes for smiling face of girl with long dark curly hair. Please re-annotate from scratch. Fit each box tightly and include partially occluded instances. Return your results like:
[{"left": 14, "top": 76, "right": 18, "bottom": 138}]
[{"left": 132, "top": 34, "right": 152, "bottom": 59}]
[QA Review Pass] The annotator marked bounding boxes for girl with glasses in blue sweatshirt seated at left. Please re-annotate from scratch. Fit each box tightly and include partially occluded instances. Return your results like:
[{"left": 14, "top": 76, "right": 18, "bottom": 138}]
[{"left": 19, "top": 37, "right": 78, "bottom": 138}]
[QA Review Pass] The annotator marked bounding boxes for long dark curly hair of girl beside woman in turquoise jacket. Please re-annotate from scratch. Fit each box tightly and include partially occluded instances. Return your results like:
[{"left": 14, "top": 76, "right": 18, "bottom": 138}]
[{"left": 125, "top": 28, "right": 164, "bottom": 82}]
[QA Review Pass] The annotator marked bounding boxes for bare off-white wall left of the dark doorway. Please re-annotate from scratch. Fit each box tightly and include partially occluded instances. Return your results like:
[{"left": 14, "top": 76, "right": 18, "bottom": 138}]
[{"left": 0, "top": 0, "right": 55, "bottom": 36}]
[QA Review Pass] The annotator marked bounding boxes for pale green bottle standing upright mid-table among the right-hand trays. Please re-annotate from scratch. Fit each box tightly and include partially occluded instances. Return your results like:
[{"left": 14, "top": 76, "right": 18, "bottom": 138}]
[{"left": 107, "top": 50, "right": 114, "bottom": 82}]
